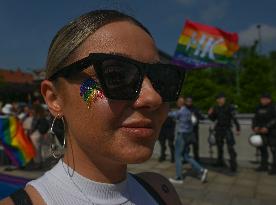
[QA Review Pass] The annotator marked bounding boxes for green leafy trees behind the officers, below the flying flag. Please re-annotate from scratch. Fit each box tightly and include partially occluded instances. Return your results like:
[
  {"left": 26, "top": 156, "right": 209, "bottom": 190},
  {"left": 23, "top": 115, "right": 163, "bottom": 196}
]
[{"left": 181, "top": 48, "right": 276, "bottom": 113}]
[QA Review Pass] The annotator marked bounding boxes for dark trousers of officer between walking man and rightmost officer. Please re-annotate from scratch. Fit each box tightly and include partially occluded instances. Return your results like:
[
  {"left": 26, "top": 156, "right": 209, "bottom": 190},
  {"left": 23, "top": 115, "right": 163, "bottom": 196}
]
[{"left": 215, "top": 129, "right": 237, "bottom": 168}]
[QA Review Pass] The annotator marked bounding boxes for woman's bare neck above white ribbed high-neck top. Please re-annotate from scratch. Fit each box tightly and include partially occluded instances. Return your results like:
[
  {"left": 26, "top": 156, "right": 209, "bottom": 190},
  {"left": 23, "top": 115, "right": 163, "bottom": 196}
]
[{"left": 63, "top": 137, "right": 127, "bottom": 184}]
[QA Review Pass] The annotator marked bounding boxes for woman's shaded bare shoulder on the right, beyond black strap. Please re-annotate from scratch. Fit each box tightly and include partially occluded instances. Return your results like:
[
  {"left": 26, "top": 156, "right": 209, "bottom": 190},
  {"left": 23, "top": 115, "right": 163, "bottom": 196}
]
[{"left": 136, "top": 172, "right": 181, "bottom": 205}]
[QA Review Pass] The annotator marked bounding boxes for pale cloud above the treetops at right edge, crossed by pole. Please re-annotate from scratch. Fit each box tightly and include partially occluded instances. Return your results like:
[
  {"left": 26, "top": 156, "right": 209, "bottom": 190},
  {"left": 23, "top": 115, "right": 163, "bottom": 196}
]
[{"left": 239, "top": 24, "right": 276, "bottom": 46}]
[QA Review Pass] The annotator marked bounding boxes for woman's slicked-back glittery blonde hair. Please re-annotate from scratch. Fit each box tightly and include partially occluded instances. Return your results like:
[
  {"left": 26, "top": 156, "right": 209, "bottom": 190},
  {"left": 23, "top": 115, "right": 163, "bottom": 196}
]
[{"left": 46, "top": 10, "right": 151, "bottom": 79}]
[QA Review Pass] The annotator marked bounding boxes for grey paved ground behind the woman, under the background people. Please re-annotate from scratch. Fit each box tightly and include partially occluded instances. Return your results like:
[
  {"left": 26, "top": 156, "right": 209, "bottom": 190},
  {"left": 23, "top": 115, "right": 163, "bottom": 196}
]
[{"left": 0, "top": 155, "right": 276, "bottom": 205}]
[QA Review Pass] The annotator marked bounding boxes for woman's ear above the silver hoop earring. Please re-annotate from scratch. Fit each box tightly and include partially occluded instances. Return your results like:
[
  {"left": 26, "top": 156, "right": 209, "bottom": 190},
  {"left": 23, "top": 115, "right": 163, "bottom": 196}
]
[{"left": 40, "top": 80, "right": 62, "bottom": 116}]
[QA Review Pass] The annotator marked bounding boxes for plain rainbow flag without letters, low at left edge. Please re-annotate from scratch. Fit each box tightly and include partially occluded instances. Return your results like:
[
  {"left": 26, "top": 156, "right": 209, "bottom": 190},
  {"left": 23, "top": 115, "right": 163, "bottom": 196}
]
[{"left": 0, "top": 116, "right": 36, "bottom": 167}]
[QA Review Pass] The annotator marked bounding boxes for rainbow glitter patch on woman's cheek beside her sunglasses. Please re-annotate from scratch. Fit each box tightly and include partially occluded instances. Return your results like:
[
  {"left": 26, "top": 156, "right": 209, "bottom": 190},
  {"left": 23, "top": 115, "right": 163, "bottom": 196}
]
[{"left": 80, "top": 78, "right": 104, "bottom": 108}]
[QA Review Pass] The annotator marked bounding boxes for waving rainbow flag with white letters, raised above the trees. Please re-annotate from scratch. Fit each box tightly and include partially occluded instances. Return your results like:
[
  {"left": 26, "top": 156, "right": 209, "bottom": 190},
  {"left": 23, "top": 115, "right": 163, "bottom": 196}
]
[{"left": 172, "top": 20, "right": 239, "bottom": 69}]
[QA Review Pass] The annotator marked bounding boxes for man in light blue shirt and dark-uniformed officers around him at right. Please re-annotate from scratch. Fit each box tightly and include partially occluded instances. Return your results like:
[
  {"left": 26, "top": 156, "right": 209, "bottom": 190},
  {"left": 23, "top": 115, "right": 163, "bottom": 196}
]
[{"left": 159, "top": 93, "right": 276, "bottom": 183}]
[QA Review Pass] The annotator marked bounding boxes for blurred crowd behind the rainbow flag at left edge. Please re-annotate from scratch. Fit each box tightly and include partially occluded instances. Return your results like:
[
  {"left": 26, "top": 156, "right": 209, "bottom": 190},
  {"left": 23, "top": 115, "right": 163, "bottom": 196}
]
[{"left": 0, "top": 100, "right": 51, "bottom": 170}]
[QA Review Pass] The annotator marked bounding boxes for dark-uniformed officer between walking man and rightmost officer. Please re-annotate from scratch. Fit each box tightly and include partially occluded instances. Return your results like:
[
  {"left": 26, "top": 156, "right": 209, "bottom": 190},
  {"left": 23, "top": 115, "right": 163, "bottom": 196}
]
[{"left": 208, "top": 93, "right": 240, "bottom": 172}]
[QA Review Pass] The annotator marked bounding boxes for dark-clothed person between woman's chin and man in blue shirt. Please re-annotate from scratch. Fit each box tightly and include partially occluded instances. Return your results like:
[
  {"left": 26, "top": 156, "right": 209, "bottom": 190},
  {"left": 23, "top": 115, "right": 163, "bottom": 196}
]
[{"left": 158, "top": 117, "right": 175, "bottom": 163}]
